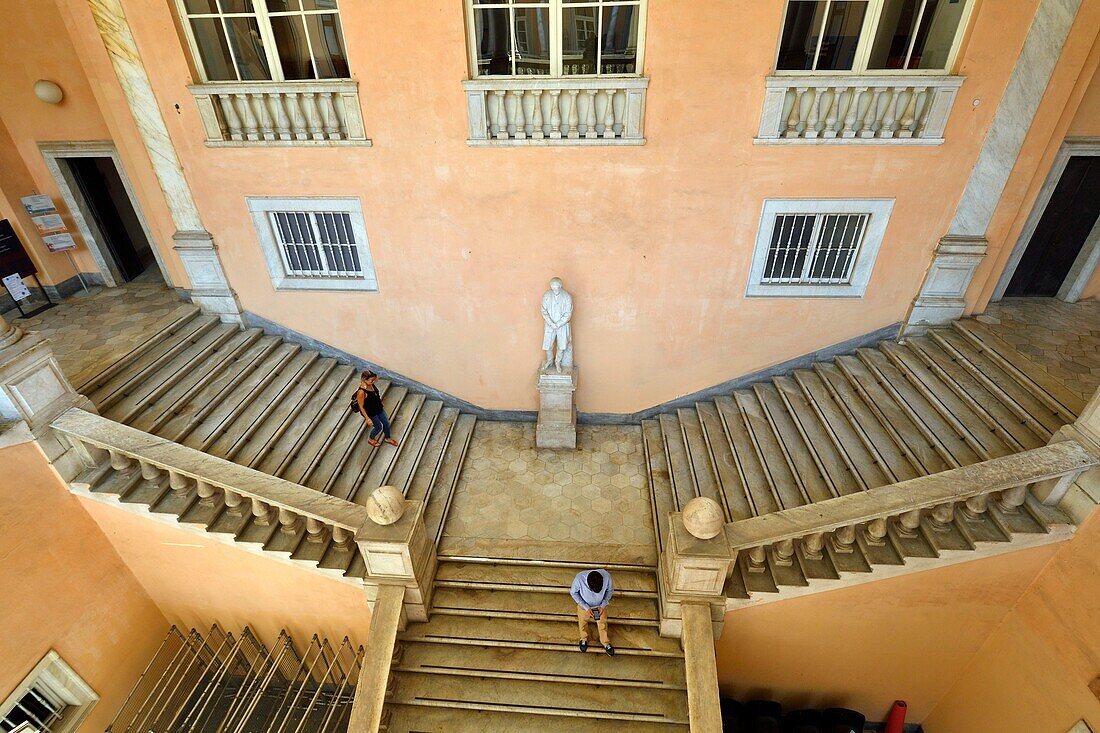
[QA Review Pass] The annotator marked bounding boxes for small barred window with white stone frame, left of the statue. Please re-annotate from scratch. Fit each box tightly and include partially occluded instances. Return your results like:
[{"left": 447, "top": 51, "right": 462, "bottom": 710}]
[{"left": 248, "top": 198, "right": 377, "bottom": 291}]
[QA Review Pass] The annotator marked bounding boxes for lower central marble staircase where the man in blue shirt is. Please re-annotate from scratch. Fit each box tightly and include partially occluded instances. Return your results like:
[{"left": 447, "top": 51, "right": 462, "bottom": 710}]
[{"left": 382, "top": 557, "right": 688, "bottom": 733}]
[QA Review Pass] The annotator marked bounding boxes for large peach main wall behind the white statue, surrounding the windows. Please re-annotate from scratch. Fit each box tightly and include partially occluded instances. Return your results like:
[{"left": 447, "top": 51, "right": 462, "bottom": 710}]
[{"left": 47, "top": 0, "right": 1035, "bottom": 412}]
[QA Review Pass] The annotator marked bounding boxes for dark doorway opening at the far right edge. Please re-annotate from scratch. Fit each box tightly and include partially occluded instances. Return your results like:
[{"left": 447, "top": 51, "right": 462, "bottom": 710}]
[{"left": 1004, "top": 155, "right": 1100, "bottom": 297}]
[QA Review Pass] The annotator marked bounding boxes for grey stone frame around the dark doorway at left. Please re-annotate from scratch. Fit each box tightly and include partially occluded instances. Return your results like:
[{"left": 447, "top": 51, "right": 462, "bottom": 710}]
[{"left": 39, "top": 140, "right": 173, "bottom": 287}]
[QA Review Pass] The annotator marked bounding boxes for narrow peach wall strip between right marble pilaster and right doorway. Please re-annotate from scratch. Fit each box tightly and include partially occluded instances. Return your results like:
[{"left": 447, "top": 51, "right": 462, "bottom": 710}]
[{"left": 967, "top": 2, "right": 1100, "bottom": 305}]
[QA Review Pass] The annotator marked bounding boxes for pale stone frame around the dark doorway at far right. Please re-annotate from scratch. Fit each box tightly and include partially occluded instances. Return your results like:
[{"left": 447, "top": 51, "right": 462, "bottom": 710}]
[{"left": 990, "top": 138, "right": 1100, "bottom": 303}]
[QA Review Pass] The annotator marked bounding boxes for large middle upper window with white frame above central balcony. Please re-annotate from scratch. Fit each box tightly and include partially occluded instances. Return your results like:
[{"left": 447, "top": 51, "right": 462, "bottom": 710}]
[{"left": 465, "top": 0, "right": 646, "bottom": 77}]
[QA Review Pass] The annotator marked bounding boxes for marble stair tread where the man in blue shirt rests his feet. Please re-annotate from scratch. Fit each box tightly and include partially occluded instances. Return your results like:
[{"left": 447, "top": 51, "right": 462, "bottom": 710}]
[{"left": 400, "top": 613, "right": 683, "bottom": 657}]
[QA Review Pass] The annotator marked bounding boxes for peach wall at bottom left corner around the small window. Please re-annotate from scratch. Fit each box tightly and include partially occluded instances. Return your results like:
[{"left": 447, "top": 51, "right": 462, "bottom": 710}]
[{"left": 0, "top": 433, "right": 168, "bottom": 731}]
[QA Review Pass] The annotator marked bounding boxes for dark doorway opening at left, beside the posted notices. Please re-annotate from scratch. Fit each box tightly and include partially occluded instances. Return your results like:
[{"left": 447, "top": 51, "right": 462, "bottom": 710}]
[{"left": 64, "top": 157, "right": 154, "bottom": 282}]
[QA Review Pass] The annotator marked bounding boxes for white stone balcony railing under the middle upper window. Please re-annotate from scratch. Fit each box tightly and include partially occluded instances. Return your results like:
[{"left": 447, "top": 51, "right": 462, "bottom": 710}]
[{"left": 462, "top": 76, "right": 649, "bottom": 145}]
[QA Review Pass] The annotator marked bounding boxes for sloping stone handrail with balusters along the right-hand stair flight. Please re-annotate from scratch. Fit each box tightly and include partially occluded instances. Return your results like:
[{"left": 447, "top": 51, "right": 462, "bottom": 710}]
[{"left": 725, "top": 440, "right": 1100, "bottom": 566}]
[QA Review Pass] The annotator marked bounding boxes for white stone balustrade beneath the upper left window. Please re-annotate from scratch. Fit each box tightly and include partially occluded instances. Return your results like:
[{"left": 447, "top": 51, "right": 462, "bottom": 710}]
[{"left": 188, "top": 79, "right": 371, "bottom": 146}]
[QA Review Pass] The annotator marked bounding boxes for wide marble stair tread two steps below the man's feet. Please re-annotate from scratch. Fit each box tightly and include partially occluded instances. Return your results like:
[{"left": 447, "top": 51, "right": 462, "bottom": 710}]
[{"left": 393, "top": 669, "right": 688, "bottom": 723}]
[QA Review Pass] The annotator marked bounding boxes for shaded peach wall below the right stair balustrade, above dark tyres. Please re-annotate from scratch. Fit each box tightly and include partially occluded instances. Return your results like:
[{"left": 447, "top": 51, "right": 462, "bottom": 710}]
[{"left": 716, "top": 540, "right": 1064, "bottom": 721}]
